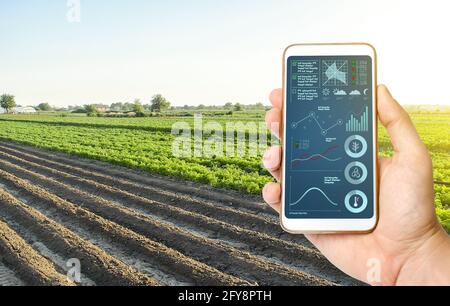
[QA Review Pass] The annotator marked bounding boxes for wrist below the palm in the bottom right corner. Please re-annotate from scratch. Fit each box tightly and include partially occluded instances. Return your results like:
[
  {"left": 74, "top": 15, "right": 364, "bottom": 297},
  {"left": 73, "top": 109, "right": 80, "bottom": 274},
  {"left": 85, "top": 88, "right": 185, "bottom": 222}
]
[{"left": 397, "top": 226, "right": 450, "bottom": 286}]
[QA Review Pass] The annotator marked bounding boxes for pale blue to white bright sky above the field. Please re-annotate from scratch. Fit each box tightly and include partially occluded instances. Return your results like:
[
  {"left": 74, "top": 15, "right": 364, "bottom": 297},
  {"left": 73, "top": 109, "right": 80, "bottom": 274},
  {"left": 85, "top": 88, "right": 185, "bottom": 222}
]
[{"left": 0, "top": 0, "right": 450, "bottom": 106}]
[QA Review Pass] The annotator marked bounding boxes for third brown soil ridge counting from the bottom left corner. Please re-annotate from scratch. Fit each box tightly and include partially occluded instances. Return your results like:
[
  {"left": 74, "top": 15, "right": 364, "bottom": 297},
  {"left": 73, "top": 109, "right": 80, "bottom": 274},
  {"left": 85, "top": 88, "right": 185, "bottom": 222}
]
[{"left": 0, "top": 170, "right": 249, "bottom": 285}]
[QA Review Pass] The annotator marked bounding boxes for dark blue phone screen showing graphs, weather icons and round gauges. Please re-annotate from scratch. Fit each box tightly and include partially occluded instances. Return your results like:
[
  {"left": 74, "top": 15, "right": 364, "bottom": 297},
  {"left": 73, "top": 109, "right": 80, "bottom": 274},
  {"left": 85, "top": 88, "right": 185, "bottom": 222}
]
[{"left": 284, "top": 56, "right": 374, "bottom": 219}]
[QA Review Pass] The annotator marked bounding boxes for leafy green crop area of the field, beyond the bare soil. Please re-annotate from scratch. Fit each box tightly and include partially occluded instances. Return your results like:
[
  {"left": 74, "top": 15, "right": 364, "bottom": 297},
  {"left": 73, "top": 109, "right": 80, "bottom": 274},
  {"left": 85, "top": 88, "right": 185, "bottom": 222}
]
[{"left": 0, "top": 111, "right": 450, "bottom": 231}]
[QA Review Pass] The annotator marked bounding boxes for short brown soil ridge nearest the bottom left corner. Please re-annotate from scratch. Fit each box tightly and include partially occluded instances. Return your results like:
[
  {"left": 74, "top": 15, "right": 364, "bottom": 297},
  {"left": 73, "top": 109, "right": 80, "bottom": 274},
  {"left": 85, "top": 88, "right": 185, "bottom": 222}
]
[{"left": 0, "top": 219, "right": 75, "bottom": 286}]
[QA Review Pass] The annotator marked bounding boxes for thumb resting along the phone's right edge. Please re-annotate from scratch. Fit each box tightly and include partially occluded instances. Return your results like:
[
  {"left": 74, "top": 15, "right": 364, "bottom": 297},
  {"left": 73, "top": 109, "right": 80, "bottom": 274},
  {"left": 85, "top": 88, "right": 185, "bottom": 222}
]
[{"left": 378, "top": 85, "right": 427, "bottom": 154}]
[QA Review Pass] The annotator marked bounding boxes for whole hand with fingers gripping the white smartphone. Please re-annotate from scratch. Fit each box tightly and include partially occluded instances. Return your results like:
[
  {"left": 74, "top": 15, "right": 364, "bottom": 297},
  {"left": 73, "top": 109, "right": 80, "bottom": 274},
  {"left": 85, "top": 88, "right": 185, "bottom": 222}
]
[{"left": 263, "top": 56, "right": 450, "bottom": 285}]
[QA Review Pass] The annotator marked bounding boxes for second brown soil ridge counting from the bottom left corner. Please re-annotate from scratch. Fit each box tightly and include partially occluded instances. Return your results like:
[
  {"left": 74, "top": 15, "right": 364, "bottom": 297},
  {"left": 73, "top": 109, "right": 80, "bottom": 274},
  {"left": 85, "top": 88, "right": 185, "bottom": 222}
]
[{"left": 0, "top": 184, "right": 157, "bottom": 286}]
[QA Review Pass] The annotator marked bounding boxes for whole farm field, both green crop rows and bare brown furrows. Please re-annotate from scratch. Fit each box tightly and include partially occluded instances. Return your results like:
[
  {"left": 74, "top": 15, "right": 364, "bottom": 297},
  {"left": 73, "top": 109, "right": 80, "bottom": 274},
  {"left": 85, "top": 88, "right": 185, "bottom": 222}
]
[{"left": 0, "top": 112, "right": 450, "bottom": 285}]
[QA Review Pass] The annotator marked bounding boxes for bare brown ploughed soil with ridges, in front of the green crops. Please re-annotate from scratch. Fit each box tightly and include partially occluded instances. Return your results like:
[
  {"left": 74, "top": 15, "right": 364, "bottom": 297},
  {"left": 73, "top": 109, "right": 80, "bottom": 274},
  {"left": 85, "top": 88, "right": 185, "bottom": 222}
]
[{"left": 0, "top": 142, "right": 356, "bottom": 285}]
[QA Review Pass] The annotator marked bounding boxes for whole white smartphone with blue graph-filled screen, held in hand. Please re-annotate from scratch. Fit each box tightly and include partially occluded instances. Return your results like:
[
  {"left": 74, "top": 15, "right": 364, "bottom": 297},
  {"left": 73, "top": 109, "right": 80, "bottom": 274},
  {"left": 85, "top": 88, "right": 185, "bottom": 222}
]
[{"left": 281, "top": 43, "right": 378, "bottom": 234}]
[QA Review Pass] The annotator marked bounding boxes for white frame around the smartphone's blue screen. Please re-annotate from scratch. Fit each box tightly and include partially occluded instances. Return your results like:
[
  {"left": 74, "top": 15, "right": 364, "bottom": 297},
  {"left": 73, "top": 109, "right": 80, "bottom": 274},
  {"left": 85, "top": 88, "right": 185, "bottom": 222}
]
[{"left": 280, "top": 43, "right": 379, "bottom": 234}]
